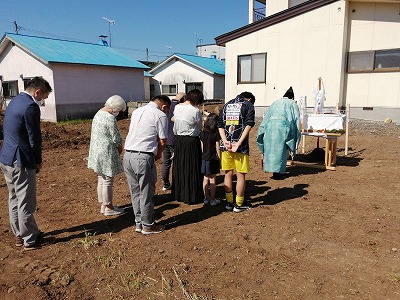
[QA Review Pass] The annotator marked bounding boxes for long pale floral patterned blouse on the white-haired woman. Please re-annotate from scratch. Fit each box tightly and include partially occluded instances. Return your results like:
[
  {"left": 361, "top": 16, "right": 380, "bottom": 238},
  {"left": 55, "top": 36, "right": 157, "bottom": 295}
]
[{"left": 88, "top": 110, "right": 124, "bottom": 177}]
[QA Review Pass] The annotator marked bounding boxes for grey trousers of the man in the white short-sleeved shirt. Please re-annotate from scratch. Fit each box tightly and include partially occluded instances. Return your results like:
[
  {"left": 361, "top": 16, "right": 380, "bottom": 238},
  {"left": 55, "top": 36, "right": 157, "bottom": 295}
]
[{"left": 123, "top": 151, "right": 157, "bottom": 228}]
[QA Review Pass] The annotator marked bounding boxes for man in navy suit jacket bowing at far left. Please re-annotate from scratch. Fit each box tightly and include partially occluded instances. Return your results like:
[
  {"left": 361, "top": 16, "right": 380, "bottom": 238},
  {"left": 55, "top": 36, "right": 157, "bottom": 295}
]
[{"left": 0, "top": 77, "right": 52, "bottom": 250}]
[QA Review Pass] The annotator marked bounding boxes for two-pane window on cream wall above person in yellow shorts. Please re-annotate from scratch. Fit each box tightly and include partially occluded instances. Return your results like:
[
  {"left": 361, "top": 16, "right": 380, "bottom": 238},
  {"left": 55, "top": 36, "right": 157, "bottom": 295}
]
[{"left": 238, "top": 53, "right": 267, "bottom": 83}]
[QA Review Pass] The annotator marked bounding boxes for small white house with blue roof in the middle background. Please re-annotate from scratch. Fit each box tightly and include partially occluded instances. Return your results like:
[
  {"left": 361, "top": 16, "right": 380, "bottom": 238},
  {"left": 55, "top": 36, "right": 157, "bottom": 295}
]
[{"left": 149, "top": 54, "right": 225, "bottom": 100}]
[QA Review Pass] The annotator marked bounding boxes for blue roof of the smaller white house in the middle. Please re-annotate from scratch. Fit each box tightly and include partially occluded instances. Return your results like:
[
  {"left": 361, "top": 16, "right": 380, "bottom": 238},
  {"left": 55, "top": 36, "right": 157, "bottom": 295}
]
[{"left": 150, "top": 53, "right": 225, "bottom": 75}]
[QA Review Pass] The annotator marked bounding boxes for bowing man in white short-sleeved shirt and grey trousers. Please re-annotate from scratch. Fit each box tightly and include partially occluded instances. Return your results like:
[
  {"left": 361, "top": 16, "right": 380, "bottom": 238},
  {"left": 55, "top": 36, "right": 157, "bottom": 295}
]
[{"left": 123, "top": 95, "right": 171, "bottom": 234}]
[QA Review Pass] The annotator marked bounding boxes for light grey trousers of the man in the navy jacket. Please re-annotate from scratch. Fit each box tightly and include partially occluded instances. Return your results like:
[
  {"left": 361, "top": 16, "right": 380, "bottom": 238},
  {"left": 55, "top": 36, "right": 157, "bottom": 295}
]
[{"left": 0, "top": 162, "right": 40, "bottom": 245}]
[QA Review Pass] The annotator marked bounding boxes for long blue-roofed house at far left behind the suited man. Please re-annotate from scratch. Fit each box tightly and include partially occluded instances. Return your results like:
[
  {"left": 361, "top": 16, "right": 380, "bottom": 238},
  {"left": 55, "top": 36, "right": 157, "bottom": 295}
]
[{"left": 0, "top": 33, "right": 148, "bottom": 122}]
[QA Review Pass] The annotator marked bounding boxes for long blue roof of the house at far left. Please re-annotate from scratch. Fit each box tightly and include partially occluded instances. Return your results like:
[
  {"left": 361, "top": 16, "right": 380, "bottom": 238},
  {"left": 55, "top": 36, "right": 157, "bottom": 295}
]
[{"left": 0, "top": 33, "right": 149, "bottom": 69}]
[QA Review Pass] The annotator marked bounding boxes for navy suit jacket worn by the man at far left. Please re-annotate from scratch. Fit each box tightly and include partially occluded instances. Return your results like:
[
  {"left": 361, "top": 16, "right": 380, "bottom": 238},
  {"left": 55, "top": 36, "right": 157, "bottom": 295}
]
[{"left": 0, "top": 93, "right": 42, "bottom": 169}]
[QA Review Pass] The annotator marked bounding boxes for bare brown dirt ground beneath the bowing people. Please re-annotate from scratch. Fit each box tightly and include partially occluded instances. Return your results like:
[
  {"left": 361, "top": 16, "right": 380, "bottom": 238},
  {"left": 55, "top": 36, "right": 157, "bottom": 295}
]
[{"left": 0, "top": 105, "right": 400, "bottom": 300}]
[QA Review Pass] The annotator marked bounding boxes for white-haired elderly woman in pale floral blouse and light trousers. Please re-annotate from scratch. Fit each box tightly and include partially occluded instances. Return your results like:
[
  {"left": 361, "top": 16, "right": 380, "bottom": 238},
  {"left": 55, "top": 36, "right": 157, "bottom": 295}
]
[{"left": 88, "top": 95, "right": 126, "bottom": 216}]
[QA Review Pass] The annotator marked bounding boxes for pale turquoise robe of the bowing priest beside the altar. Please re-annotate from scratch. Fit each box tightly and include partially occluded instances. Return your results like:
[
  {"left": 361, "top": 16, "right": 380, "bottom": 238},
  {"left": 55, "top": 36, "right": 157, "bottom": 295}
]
[{"left": 257, "top": 98, "right": 301, "bottom": 174}]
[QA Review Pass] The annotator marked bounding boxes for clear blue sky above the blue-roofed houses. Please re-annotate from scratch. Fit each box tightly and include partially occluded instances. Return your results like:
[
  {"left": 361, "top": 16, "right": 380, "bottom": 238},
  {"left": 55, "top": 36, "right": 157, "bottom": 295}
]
[{"left": 0, "top": 0, "right": 248, "bottom": 61}]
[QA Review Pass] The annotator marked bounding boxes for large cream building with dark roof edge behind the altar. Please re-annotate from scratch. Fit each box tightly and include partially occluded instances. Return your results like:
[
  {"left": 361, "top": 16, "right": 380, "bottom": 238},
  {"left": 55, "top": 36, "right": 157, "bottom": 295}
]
[{"left": 215, "top": 0, "right": 400, "bottom": 121}]
